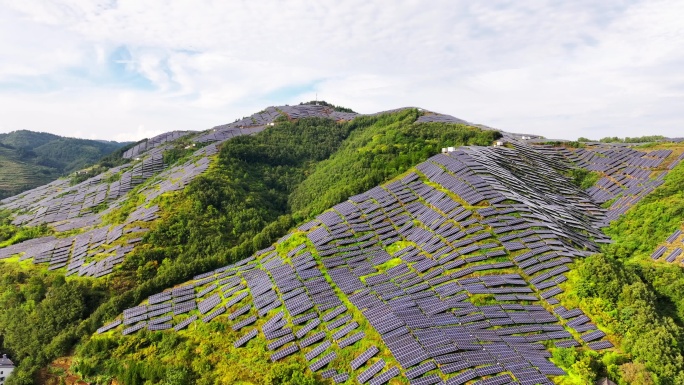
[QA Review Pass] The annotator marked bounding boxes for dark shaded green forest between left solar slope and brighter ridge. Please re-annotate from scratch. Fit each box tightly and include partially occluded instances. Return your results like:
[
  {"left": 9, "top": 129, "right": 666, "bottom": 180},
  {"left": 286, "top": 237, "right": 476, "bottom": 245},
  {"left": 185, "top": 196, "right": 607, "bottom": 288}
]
[{"left": 149, "top": 119, "right": 349, "bottom": 260}]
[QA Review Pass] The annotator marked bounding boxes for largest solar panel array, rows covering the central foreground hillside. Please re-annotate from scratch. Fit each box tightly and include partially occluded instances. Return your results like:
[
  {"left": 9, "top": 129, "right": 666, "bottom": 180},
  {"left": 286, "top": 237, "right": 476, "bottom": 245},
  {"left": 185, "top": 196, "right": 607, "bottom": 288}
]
[{"left": 105, "top": 143, "right": 684, "bottom": 383}]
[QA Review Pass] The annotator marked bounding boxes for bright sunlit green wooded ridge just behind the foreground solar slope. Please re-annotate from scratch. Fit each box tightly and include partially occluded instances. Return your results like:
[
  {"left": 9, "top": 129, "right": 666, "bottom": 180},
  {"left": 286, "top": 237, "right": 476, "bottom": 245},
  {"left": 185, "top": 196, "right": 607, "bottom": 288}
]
[{"left": 289, "top": 110, "right": 500, "bottom": 220}]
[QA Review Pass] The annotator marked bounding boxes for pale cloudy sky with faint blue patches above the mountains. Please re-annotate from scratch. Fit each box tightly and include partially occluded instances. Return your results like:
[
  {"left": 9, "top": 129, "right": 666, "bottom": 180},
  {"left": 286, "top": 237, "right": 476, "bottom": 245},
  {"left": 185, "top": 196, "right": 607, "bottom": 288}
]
[{"left": 0, "top": 0, "right": 684, "bottom": 140}]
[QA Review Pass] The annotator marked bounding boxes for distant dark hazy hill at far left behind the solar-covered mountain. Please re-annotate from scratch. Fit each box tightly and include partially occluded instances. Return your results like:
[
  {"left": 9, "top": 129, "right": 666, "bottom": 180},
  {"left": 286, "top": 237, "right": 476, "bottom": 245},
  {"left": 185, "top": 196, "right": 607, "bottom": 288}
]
[{"left": 0, "top": 130, "right": 128, "bottom": 198}]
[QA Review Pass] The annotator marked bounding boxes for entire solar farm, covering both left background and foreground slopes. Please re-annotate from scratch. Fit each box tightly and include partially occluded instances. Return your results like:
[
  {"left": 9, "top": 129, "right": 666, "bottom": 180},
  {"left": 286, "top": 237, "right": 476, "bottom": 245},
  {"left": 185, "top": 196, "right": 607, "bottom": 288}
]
[{"left": 0, "top": 105, "right": 684, "bottom": 385}]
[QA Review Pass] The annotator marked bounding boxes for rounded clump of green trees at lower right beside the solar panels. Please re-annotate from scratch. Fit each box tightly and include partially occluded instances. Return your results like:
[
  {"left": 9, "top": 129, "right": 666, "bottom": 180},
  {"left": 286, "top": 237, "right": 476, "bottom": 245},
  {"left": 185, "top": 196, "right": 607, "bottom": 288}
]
[{"left": 563, "top": 254, "right": 684, "bottom": 385}]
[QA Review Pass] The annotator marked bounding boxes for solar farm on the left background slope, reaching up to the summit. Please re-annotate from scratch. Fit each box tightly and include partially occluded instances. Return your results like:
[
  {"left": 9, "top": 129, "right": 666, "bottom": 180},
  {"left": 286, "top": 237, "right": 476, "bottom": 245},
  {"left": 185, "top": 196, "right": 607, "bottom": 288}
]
[{"left": 0, "top": 106, "right": 364, "bottom": 277}]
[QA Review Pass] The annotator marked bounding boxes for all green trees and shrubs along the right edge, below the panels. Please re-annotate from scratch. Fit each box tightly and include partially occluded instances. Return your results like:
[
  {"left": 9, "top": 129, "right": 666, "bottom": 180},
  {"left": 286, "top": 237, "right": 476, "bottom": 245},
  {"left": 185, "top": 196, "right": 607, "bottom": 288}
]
[{"left": 563, "top": 160, "right": 684, "bottom": 385}]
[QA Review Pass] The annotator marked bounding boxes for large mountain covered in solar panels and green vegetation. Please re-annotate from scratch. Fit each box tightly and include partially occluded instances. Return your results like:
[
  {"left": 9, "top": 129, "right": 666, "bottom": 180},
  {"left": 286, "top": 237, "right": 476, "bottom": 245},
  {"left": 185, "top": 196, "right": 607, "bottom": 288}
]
[{"left": 0, "top": 102, "right": 684, "bottom": 384}]
